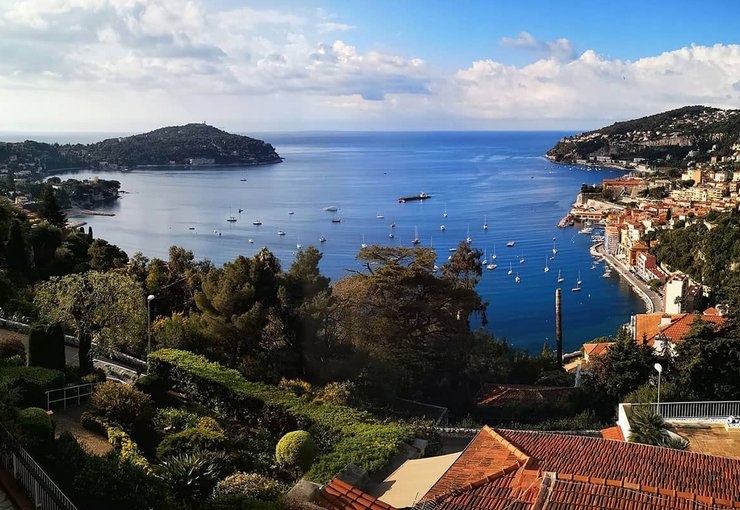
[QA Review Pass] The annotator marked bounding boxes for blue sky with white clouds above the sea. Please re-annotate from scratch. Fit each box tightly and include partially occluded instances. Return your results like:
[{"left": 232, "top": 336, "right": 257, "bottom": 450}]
[{"left": 0, "top": 0, "right": 740, "bottom": 133}]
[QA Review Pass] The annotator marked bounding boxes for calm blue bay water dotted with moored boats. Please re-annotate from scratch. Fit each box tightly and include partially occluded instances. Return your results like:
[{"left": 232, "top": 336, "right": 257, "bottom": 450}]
[{"left": 50, "top": 132, "right": 644, "bottom": 350}]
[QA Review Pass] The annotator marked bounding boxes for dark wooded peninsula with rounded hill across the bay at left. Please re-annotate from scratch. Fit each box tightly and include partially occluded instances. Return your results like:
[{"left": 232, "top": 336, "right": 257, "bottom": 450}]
[{"left": 0, "top": 124, "right": 282, "bottom": 179}]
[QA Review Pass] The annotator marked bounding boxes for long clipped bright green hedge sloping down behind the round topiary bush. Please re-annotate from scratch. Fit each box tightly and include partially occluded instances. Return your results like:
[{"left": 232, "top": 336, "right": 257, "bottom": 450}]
[{"left": 148, "top": 349, "right": 413, "bottom": 483}]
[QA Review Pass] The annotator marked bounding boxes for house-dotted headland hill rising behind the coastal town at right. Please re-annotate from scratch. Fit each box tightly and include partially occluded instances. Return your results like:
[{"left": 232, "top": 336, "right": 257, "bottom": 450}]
[{"left": 547, "top": 106, "right": 740, "bottom": 165}]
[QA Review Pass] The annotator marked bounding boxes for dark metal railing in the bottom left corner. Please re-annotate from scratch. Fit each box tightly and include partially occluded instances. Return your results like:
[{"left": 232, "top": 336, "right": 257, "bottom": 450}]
[{"left": 0, "top": 426, "right": 77, "bottom": 510}]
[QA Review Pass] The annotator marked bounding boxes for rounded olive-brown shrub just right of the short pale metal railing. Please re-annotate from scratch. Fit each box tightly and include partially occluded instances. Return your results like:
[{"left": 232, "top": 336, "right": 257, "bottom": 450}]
[{"left": 88, "top": 381, "right": 154, "bottom": 433}]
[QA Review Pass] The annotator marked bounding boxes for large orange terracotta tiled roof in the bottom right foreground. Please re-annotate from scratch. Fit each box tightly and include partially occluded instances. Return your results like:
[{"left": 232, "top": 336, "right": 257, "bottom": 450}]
[{"left": 417, "top": 427, "right": 740, "bottom": 510}]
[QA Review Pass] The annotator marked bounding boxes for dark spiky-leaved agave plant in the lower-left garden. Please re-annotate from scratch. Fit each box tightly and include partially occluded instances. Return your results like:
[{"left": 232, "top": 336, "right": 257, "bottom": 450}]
[{"left": 157, "top": 452, "right": 227, "bottom": 505}]
